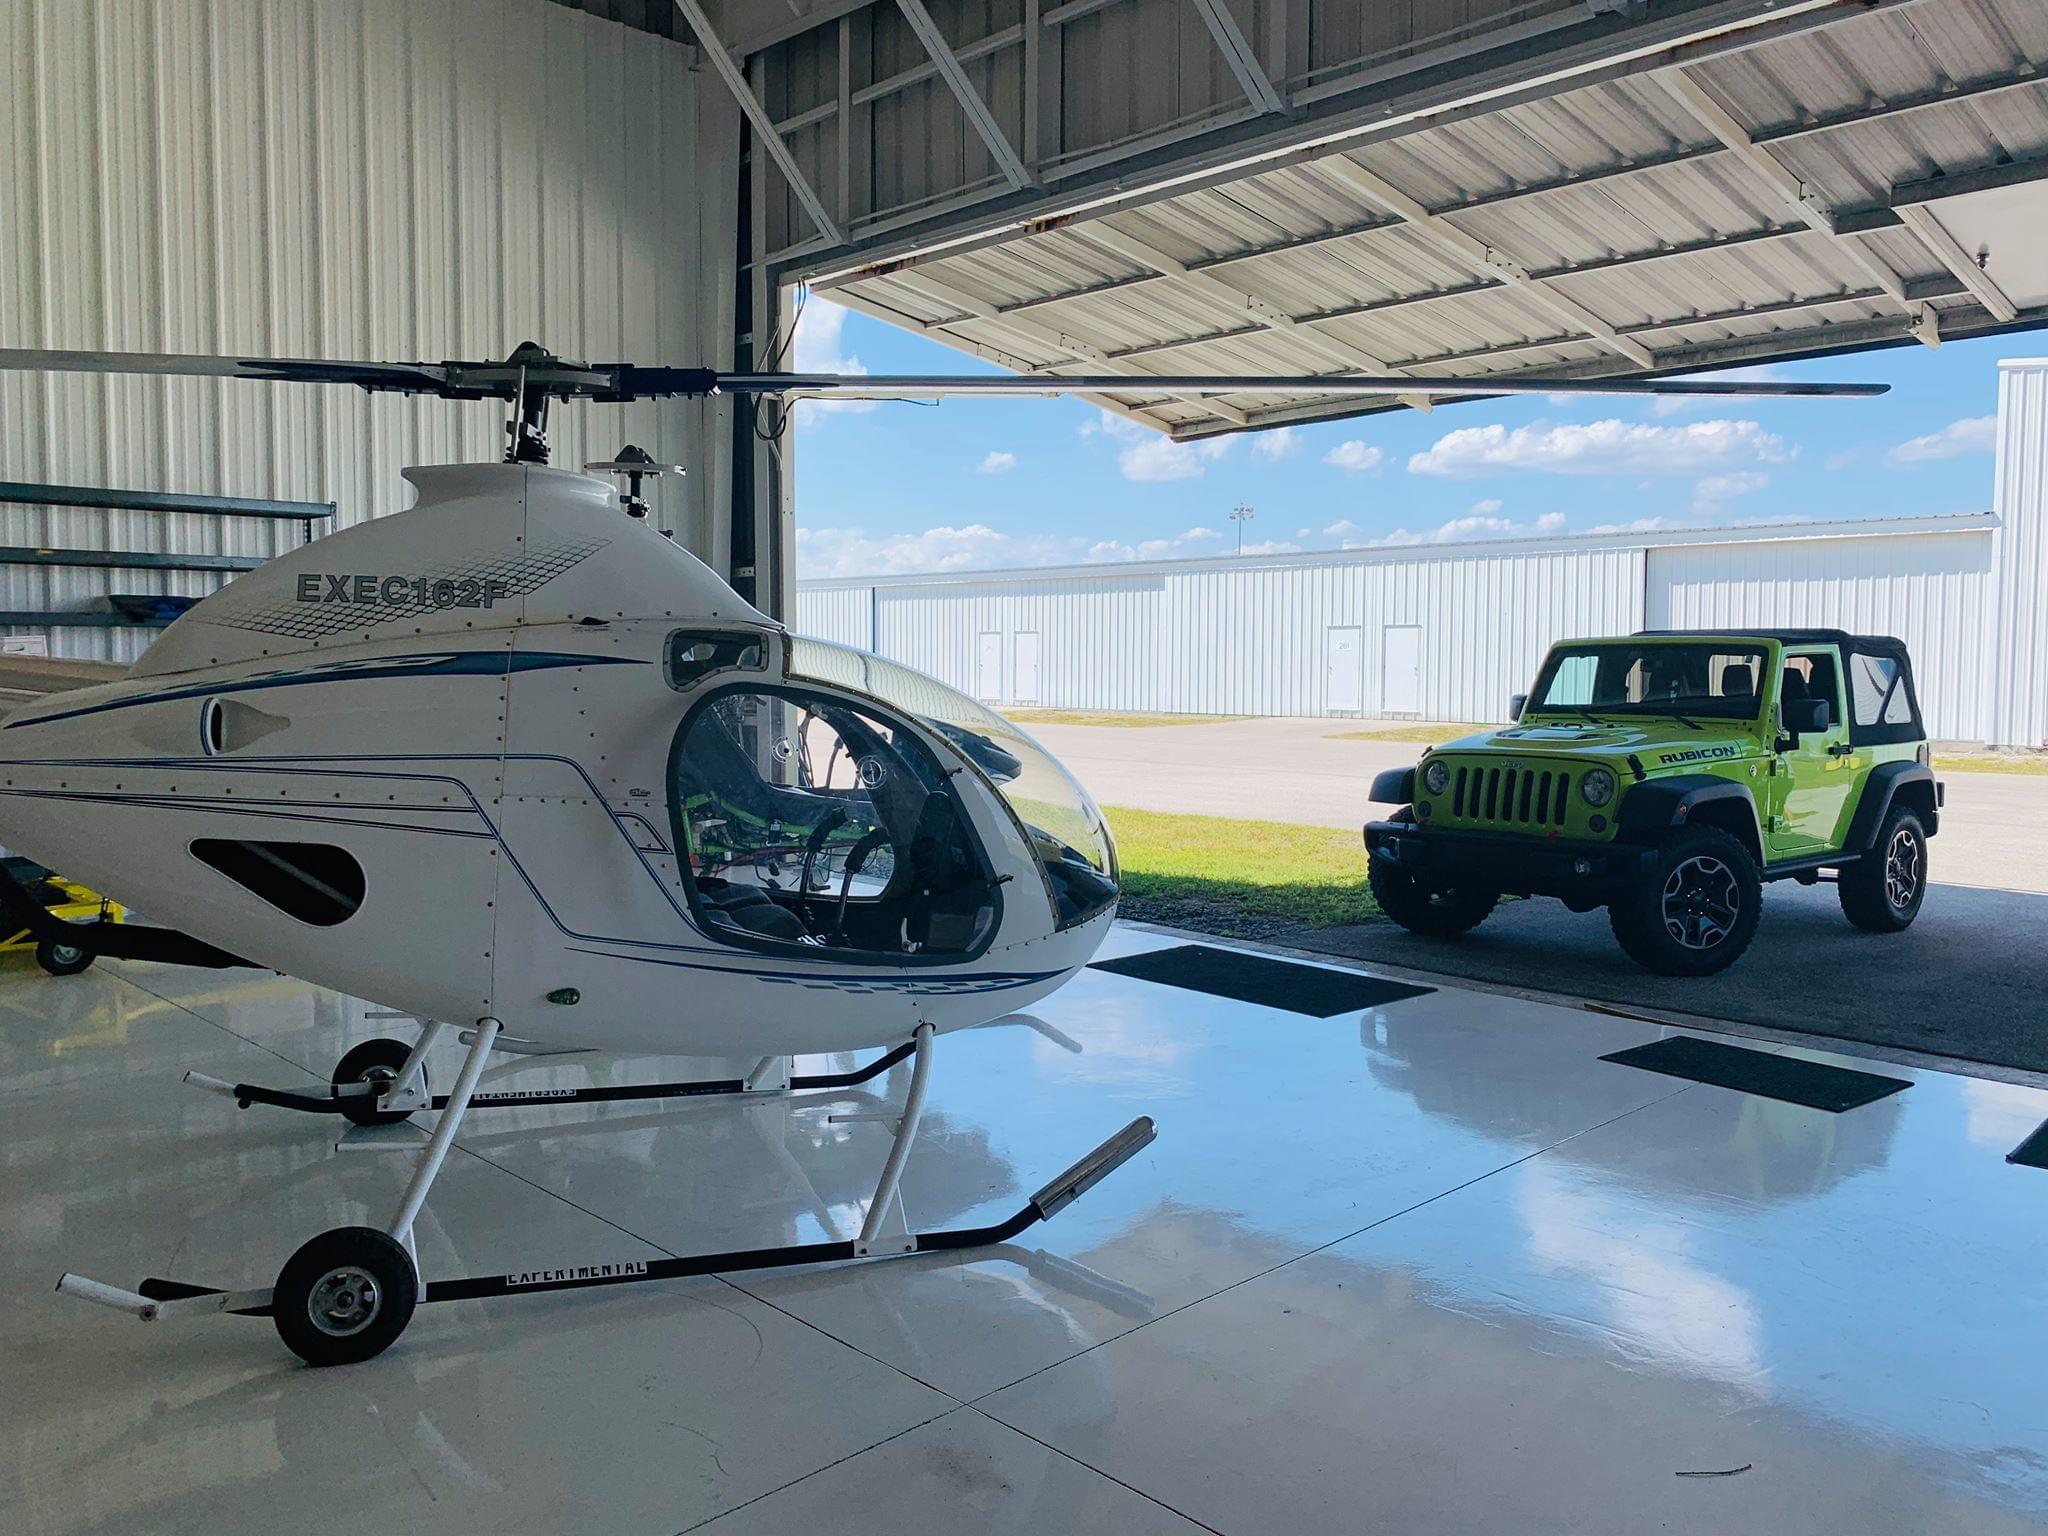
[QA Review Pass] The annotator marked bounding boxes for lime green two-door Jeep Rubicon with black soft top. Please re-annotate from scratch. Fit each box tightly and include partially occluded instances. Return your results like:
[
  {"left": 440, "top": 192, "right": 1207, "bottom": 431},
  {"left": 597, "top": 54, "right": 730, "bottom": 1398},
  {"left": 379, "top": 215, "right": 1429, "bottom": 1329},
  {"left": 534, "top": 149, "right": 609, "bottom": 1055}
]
[{"left": 1366, "top": 629, "right": 1942, "bottom": 977}]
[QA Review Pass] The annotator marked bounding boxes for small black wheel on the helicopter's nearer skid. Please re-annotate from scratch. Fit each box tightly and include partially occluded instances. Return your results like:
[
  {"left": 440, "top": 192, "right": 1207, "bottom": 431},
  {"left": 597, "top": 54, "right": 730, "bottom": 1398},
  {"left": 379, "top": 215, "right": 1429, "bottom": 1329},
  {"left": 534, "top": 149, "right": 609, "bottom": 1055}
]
[{"left": 270, "top": 1227, "right": 420, "bottom": 1366}]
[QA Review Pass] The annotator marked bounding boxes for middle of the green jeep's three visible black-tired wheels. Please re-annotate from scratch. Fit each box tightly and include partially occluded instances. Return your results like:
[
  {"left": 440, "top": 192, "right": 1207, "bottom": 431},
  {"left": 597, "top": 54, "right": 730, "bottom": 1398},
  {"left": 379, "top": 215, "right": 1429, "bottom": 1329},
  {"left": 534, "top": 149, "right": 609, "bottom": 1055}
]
[{"left": 1608, "top": 827, "right": 1763, "bottom": 977}]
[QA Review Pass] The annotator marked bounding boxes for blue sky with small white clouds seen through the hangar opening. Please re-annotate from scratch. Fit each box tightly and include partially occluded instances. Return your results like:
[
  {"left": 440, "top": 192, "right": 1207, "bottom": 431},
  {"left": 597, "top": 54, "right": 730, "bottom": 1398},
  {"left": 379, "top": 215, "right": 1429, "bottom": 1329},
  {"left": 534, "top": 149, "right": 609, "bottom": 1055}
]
[{"left": 795, "top": 297, "right": 2015, "bottom": 578}]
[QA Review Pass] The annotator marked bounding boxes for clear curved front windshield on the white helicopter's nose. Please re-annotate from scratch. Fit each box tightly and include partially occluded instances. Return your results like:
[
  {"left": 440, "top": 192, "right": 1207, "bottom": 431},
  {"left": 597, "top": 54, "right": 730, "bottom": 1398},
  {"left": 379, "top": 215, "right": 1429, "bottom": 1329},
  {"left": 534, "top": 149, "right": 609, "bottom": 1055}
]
[{"left": 788, "top": 635, "right": 1116, "bottom": 928}]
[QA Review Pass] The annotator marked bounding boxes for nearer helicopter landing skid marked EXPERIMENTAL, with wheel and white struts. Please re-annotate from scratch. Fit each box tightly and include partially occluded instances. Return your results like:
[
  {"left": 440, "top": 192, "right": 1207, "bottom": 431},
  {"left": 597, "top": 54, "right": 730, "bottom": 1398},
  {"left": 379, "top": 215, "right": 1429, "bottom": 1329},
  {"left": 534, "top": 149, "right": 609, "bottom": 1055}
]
[{"left": 57, "top": 1020, "right": 1155, "bottom": 1366}]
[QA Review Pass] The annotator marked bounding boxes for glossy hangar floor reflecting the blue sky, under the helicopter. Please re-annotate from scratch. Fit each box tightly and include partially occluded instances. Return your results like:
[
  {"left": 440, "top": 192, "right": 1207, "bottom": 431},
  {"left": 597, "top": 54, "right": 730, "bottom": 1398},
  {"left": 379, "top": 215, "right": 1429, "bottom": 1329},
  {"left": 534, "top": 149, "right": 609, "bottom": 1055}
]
[{"left": 0, "top": 932, "right": 2048, "bottom": 1536}]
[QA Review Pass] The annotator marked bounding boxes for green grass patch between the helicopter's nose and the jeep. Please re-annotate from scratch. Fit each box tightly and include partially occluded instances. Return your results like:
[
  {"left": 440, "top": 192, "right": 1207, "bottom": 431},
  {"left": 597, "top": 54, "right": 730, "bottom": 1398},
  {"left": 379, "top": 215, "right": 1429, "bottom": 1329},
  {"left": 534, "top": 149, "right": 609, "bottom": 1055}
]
[{"left": 1104, "top": 807, "right": 1380, "bottom": 936}]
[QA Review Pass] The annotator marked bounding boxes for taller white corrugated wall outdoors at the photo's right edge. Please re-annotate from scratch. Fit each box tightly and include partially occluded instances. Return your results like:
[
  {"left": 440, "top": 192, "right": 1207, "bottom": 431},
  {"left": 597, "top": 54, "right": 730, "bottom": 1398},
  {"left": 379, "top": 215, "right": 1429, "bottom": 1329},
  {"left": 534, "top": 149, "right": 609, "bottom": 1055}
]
[{"left": 1985, "top": 358, "right": 2048, "bottom": 748}]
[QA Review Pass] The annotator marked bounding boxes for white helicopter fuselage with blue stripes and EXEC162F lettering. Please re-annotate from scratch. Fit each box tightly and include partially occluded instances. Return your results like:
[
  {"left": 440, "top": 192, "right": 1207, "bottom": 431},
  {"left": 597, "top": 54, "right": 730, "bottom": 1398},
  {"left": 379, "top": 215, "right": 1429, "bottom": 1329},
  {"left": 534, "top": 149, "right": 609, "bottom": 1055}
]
[{"left": 0, "top": 465, "right": 1114, "bottom": 1057}]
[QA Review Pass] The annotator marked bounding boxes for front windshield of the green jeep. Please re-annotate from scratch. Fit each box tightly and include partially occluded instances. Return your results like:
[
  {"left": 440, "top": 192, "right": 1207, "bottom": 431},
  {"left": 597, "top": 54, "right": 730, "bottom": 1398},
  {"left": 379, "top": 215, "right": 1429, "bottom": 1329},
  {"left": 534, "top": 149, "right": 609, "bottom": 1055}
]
[{"left": 1524, "top": 641, "right": 1769, "bottom": 723}]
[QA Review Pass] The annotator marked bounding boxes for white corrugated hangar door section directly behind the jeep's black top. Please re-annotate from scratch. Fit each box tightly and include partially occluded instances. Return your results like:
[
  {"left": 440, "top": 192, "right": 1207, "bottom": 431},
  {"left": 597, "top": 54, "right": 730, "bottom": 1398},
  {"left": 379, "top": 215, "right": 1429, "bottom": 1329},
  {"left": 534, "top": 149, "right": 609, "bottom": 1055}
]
[{"left": 1649, "top": 535, "right": 1993, "bottom": 741}]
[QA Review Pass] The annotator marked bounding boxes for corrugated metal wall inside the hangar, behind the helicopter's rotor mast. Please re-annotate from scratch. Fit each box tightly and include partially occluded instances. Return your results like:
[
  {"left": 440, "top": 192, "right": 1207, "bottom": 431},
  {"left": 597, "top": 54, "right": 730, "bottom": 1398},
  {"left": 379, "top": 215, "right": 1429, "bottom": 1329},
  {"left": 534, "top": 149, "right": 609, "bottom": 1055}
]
[{"left": 0, "top": 0, "right": 737, "bottom": 657}]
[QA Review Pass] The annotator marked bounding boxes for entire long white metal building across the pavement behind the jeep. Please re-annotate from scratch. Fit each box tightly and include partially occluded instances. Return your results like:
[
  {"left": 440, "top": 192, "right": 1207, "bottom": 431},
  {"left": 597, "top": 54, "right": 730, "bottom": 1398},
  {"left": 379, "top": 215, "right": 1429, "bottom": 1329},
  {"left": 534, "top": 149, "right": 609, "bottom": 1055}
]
[{"left": 797, "top": 362, "right": 2048, "bottom": 745}]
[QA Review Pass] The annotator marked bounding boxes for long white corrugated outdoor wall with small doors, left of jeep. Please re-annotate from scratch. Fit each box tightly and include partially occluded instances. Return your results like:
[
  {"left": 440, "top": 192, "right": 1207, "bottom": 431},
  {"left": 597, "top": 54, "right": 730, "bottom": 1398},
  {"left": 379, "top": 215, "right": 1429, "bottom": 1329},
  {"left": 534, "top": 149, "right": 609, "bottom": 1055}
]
[{"left": 797, "top": 549, "right": 1642, "bottom": 721}]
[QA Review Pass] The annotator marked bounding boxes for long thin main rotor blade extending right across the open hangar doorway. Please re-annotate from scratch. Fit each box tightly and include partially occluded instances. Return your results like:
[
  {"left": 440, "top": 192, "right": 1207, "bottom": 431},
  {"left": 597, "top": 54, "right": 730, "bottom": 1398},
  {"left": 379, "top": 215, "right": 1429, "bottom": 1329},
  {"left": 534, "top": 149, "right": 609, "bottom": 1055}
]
[{"left": 715, "top": 373, "right": 1890, "bottom": 399}]
